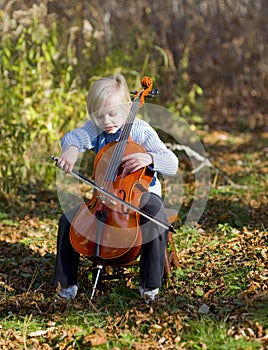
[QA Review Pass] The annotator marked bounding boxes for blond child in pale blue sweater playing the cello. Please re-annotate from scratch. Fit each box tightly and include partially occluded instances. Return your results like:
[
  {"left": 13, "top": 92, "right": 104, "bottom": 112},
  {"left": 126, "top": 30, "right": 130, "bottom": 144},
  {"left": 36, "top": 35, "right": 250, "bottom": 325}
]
[{"left": 52, "top": 74, "right": 178, "bottom": 301}]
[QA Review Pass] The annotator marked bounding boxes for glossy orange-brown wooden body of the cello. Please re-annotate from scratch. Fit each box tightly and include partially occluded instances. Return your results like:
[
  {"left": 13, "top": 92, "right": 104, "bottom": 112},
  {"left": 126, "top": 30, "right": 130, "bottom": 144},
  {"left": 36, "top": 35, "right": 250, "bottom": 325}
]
[{"left": 70, "top": 139, "right": 153, "bottom": 266}]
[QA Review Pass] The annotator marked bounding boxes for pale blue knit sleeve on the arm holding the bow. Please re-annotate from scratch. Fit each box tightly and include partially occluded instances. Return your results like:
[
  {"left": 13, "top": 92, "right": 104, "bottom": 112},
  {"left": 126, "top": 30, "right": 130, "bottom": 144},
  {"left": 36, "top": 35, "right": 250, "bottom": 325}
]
[{"left": 61, "top": 120, "right": 97, "bottom": 152}]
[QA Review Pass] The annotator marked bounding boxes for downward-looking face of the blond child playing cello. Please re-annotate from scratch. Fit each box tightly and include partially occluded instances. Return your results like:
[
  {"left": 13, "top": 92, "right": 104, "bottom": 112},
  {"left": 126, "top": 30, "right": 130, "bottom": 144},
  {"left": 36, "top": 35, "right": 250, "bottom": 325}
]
[{"left": 94, "top": 95, "right": 131, "bottom": 134}]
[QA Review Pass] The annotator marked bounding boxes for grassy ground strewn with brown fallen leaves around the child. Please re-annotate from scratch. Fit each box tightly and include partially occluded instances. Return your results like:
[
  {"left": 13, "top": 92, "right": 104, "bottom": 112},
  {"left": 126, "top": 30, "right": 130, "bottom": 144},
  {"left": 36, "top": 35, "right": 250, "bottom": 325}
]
[{"left": 0, "top": 131, "right": 268, "bottom": 350}]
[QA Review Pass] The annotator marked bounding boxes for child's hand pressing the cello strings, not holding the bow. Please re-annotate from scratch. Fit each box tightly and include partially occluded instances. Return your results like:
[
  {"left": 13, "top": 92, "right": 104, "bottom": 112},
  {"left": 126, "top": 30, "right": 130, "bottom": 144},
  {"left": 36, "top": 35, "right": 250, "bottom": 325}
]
[{"left": 122, "top": 153, "right": 153, "bottom": 177}]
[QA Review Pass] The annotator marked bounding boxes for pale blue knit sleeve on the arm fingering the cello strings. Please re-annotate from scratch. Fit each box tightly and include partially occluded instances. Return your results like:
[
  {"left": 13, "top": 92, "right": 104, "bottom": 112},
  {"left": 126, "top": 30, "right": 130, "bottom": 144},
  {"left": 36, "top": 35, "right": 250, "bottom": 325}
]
[{"left": 132, "top": 119, "right": 179, "bottom": 176}]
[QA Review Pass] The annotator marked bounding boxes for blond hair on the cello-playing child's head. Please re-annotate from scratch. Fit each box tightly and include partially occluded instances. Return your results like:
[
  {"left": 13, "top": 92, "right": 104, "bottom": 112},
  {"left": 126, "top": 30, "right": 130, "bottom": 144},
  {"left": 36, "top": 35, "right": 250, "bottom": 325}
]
[{"left": 87, "top": 74, "right": 130, "bottom": 115}]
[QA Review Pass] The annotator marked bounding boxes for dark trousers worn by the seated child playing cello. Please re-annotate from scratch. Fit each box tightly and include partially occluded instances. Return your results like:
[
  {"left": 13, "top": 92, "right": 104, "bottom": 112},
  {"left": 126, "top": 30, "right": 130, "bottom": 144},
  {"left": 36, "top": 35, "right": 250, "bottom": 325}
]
[{"left": 52, "top": 192, "right": 168, "bottom": 288}]
